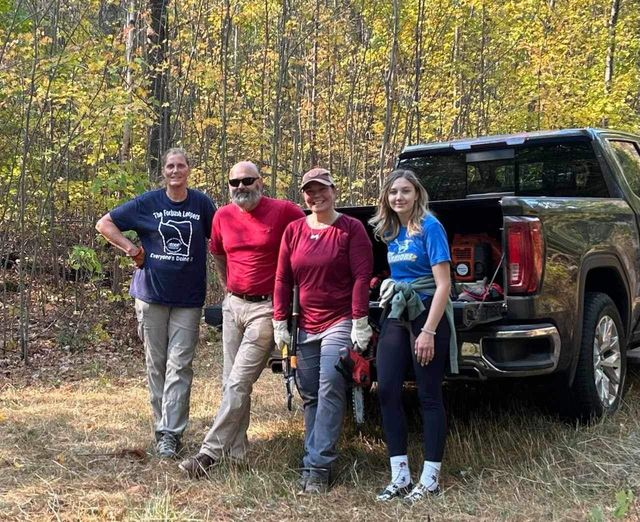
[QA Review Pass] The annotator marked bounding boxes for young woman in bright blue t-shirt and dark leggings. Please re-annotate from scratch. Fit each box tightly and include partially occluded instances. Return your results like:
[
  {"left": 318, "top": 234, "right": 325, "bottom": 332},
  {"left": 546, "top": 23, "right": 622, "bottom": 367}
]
[{"left": 370, "top": 170, "right": 452, "bottom": 502}]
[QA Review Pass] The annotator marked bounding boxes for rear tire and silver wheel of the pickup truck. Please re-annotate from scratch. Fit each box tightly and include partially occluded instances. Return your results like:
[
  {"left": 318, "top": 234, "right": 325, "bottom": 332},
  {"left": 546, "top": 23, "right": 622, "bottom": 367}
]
[{"left": 571, "top": 292, "right": 627, "bottom": 419}]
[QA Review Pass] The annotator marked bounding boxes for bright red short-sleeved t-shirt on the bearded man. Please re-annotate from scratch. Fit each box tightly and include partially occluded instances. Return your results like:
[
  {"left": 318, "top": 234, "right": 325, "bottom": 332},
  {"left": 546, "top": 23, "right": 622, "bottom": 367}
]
[{"left": 209, "top": 196, "right": 304, "bottom": 295}]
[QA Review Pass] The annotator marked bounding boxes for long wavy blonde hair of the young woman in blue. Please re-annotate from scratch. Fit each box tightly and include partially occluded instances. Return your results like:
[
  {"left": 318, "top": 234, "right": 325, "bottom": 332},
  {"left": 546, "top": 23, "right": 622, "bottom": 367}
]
[{"left": 369, "top": 169, "right": 429, "bottom": 243}]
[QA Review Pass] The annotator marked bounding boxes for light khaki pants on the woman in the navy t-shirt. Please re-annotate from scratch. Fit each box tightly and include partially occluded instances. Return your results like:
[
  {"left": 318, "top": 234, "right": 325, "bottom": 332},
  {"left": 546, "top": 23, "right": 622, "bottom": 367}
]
[{"left": 135, "top": 299, "right": 202, "bottom": 440}]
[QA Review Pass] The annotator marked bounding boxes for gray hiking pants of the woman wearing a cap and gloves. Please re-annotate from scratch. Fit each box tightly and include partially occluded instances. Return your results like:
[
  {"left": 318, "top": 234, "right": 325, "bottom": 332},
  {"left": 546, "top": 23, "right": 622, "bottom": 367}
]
[{"left": 297, "top": 320, "right": 351, "bottom": 480}]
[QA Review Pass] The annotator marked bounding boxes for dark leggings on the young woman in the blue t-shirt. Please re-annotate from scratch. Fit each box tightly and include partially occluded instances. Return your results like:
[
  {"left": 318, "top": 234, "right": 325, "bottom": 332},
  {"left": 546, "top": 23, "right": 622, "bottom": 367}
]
[{"left": 376, "top": 299, "right": 451, "bottom": 462}]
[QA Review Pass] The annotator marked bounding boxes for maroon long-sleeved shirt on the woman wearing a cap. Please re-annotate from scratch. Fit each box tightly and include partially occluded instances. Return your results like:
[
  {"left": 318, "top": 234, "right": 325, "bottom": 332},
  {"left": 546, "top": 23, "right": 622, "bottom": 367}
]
[{"left": 273, "top": 214, "right": 373, "bottom": 333}]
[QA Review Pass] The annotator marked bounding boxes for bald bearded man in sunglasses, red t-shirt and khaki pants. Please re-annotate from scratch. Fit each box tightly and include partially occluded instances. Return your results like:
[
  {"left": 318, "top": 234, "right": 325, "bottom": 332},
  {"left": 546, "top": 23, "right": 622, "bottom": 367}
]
[{"left": 179, "top": 161, "right": 304, "bottom": 478}]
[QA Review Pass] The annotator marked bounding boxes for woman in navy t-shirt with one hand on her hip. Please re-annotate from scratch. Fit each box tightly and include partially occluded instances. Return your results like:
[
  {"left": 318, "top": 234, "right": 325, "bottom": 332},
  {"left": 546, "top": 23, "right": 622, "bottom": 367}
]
[{"left": 96, "top": 149, "right": 215, "bottom": 457}]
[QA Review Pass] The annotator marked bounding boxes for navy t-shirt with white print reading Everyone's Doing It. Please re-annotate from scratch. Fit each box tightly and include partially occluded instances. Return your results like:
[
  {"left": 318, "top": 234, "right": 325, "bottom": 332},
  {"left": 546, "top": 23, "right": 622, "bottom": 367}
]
[{"left": 110, "top": 189, "right": 215, "bottom": 308}]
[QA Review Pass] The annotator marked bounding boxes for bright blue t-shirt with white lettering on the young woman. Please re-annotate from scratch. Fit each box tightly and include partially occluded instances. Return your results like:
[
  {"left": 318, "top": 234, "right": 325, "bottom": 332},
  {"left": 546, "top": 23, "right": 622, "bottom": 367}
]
[{"left": 387, "top": 214, "right": 451, "bottom": 283}]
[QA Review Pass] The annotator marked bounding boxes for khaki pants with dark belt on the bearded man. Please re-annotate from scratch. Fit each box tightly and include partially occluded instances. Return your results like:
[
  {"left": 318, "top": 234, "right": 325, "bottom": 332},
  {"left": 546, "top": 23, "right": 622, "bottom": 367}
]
[{"left": 200, "top": 295, "right": 274, "bottom": 460}]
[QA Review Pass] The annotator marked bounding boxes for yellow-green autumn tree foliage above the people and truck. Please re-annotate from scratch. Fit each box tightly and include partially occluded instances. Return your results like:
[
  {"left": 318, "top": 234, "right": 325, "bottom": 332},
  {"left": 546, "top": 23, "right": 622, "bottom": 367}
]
[{"left": 5, "top": 0, "right": 640, "bottom": 205}]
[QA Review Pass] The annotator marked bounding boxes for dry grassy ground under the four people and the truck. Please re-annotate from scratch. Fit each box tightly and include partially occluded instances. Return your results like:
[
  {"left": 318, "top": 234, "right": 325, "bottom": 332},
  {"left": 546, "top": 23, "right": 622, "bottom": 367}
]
[{"left": 0, "top": 330, "right": 640, "bottom": 521}]
